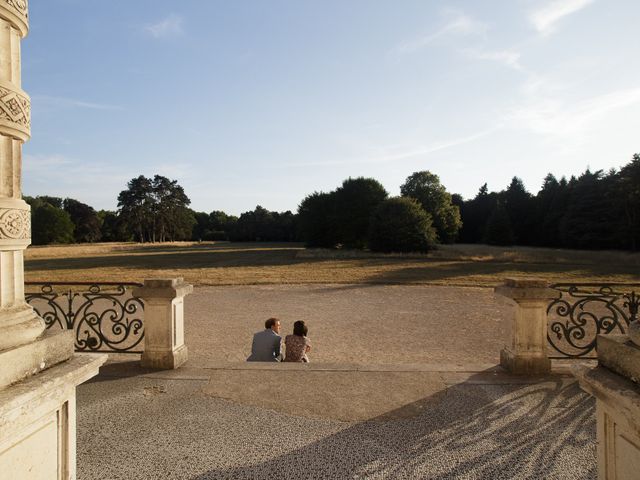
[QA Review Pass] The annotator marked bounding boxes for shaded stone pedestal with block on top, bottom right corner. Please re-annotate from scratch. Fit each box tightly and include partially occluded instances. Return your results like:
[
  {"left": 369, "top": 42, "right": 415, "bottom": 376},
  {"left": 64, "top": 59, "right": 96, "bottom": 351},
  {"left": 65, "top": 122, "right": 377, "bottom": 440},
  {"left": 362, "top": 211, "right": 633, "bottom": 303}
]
[{"left": 573, "top": 335, "right": 640, "bottom": 480}]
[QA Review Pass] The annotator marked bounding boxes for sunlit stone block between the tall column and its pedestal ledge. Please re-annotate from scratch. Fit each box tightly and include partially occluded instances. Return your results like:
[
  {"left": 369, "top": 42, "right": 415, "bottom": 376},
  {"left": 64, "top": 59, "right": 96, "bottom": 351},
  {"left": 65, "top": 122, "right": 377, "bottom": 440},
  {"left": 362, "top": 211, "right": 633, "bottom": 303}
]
[{"left": 0, "top": 329, "right": 74, "bottom": 389}]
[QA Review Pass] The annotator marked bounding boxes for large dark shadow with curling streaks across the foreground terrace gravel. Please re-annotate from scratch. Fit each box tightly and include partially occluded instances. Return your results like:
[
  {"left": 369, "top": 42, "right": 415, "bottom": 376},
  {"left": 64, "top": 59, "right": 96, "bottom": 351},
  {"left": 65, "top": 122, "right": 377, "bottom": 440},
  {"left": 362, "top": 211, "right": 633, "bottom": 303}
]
[{"left": 191, "top": 377, "right": 596, "bottom": 480}]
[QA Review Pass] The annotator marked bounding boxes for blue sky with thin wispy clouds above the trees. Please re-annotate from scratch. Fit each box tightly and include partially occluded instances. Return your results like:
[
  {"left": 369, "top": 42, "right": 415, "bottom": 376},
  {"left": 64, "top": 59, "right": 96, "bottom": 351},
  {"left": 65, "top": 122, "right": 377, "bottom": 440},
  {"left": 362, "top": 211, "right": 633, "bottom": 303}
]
[{"left": 22, "top": 0, "right": 640, "bottom": 215}]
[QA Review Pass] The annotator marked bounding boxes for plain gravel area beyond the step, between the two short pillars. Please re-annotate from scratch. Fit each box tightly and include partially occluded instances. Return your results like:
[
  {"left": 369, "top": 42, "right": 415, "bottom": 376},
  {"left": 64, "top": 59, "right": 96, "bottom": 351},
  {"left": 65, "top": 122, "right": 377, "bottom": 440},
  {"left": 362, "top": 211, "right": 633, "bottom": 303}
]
[{"left": 185, "top": 285, "right": 513, "bottom": 366}]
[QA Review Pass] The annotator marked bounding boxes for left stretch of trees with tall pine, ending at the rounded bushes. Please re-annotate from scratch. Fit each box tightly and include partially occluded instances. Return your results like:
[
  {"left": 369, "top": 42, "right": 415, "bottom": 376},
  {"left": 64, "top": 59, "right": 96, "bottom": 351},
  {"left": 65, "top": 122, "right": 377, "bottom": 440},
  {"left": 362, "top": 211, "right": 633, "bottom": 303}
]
[{"left": 24, "top": 175, "right": 298, "bottom": 245}]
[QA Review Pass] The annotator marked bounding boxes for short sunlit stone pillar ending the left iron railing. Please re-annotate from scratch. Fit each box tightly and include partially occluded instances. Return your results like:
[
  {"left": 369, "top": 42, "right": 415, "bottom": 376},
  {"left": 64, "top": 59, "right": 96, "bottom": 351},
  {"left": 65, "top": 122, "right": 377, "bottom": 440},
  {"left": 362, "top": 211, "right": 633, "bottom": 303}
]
[{"left": 133, "top": 278, "right": 193, "bottom": 370}]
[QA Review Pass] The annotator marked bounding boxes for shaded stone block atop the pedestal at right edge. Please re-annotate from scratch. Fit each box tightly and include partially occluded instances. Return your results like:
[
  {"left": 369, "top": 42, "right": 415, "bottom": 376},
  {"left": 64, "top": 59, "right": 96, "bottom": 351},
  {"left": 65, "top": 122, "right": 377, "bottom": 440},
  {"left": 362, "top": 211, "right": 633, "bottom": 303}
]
[{"left": 598, "top": 334, "right": 640, "bottom": 383}]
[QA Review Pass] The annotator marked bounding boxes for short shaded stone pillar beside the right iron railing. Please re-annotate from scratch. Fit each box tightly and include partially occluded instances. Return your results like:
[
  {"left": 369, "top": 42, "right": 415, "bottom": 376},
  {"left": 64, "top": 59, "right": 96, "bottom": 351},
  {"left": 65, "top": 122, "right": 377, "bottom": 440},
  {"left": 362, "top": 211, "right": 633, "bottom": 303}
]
[{"left": 495, "top": 279, "right": 557, "bottom": 375}]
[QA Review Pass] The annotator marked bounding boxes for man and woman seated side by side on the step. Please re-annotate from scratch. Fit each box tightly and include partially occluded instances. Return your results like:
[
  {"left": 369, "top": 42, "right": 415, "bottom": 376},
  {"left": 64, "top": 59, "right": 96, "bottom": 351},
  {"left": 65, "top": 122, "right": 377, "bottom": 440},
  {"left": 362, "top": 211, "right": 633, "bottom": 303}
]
[{"left": 247, "top": 318, "right": 311, "bottom": 362}]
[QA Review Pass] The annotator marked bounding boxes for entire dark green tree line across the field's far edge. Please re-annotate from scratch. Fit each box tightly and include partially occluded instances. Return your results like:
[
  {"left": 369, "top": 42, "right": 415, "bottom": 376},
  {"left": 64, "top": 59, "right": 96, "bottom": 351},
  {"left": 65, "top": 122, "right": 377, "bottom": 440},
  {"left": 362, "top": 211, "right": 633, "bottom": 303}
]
[{"left": 25, "top": 154, "right": 640, "bottom": 252}]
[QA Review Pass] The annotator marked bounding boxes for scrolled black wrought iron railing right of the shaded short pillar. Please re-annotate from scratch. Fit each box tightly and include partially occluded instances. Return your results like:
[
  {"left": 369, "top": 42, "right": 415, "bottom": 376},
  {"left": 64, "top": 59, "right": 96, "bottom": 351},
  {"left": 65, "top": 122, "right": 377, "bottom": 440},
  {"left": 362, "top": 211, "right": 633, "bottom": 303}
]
[{"left": 547, "top": 283, "right": 640, "bottom": 358}]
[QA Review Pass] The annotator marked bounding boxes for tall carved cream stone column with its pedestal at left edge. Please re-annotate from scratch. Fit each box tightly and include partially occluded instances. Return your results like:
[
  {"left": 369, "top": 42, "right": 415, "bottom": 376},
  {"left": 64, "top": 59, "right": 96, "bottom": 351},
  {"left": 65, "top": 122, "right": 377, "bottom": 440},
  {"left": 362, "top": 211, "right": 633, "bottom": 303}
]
[{"left": 0, "top": 0, "right": 106, "bottom": 480}]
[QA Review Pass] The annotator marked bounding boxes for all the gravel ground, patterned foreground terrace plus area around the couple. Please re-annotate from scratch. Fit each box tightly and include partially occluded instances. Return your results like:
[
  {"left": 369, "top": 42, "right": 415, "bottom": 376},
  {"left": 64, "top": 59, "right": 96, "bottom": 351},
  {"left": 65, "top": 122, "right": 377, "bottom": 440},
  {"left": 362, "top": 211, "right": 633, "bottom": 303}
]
[{"left": 78, "top": 285, "right": 597, "bottom": 480}]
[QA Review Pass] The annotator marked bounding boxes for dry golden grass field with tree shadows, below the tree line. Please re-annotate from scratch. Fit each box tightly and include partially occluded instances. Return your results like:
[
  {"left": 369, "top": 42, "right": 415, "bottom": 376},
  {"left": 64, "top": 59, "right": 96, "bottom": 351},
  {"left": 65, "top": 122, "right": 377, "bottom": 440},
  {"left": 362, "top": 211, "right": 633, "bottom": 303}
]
[{"left": 25, "top": 242, "right": 640, "bottom": 287}]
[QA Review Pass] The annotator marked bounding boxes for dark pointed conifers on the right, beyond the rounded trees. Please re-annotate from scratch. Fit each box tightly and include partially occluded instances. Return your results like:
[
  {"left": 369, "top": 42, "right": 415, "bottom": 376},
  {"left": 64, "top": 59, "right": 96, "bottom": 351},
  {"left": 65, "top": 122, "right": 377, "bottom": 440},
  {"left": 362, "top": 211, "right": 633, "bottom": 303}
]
[{"left": 454, "top": 154, "right": 640, "bottom": 250}]
